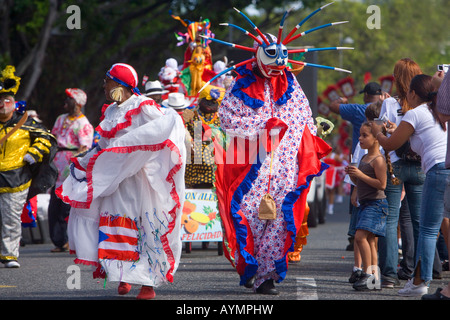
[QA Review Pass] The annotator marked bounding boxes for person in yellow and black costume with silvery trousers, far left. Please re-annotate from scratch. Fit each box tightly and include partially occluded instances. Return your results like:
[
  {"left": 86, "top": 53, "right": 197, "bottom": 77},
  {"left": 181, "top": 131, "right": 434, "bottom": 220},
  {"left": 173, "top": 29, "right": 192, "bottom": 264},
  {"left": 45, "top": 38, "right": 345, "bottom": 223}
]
[{"left": 0, "top": 66, "right": 54, "bottom": 268}]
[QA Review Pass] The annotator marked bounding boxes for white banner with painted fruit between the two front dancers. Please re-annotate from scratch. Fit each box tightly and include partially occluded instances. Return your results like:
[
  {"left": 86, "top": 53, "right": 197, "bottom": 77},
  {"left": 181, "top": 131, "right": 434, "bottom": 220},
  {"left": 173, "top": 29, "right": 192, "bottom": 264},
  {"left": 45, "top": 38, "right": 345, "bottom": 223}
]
[{"left": 181, "top": 189, "right": 222, "bottom": 242}]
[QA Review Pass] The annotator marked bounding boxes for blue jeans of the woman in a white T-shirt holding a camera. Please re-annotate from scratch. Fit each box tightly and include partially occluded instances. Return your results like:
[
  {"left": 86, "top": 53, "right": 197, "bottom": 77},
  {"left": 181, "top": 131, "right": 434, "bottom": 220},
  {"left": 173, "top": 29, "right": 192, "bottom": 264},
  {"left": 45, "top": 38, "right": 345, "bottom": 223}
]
[{"left": 416, "top": 162, "right": 450, "bottom": 283}]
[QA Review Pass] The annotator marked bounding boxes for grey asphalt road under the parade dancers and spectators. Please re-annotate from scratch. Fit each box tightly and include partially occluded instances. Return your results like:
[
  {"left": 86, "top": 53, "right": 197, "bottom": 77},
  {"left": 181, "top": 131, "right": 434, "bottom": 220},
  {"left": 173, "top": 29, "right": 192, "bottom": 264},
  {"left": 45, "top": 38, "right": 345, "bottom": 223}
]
[{"left": 0, "top": 196, "right": 450, "bottom": 306}]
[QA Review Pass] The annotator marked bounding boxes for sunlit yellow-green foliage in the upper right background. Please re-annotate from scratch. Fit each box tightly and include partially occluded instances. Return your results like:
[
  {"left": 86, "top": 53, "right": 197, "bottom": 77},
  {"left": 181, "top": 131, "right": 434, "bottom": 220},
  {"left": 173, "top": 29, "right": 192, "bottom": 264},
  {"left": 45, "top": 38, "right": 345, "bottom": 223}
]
[{"left": 287, "top": 0, "right": 450, "bottom": 102}]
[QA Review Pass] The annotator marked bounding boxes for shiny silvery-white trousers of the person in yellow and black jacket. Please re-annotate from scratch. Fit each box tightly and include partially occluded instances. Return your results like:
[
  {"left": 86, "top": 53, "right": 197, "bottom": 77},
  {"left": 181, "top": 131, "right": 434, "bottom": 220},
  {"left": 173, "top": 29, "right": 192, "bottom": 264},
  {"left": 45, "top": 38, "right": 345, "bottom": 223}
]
[{"left": 0, "top": 189, "right": 28, "bottom": 261}]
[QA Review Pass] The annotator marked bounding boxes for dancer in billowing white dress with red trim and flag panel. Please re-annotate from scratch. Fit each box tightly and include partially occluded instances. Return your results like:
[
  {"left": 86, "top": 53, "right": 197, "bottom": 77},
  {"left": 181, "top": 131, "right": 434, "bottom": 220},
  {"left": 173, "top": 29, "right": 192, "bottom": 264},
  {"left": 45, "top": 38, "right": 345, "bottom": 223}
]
[{"left": 57, "top": 63, "right": 186, "bottom": 299}]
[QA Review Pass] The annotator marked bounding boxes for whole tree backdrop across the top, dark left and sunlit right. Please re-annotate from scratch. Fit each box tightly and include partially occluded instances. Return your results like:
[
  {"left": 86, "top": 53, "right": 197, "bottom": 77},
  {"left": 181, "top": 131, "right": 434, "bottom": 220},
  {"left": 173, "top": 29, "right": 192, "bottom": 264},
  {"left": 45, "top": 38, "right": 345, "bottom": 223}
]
[{"left": 0, "top": 0, "right": 450, "bottom": 127}]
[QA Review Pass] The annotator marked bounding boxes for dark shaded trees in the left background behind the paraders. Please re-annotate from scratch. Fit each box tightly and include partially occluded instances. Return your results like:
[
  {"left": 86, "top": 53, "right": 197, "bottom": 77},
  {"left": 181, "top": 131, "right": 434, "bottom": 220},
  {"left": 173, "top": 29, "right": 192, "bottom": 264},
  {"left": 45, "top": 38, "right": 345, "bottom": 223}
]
[{"left": 0, "top": 0, "right": 320, "bottom": 127}]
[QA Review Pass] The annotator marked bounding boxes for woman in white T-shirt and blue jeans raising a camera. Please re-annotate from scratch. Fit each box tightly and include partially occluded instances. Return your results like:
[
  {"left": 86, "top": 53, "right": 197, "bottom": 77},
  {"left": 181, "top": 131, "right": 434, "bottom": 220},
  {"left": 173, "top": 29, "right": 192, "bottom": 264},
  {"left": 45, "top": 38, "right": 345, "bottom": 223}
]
[{"left": 372, "top": 74, "right": 450, "bottom": 297}]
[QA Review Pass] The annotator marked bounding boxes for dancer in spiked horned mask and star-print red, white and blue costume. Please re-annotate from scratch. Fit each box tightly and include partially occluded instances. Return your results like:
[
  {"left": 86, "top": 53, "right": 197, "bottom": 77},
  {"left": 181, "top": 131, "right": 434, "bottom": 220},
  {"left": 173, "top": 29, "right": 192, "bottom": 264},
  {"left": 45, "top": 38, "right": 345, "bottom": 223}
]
[{"left": 204, "top": 6, "right": 356, "bottom": 295}]
